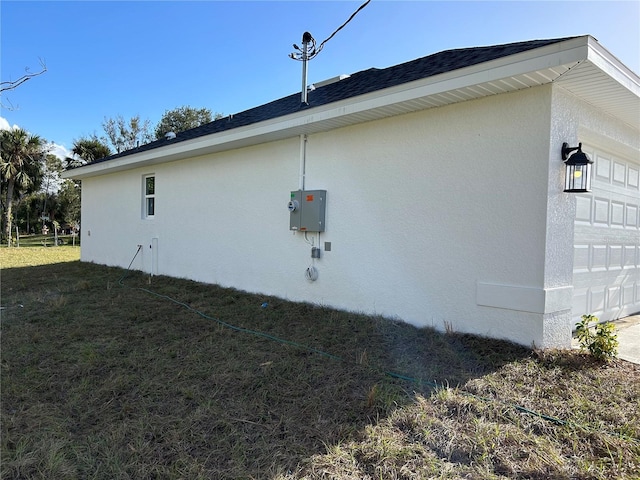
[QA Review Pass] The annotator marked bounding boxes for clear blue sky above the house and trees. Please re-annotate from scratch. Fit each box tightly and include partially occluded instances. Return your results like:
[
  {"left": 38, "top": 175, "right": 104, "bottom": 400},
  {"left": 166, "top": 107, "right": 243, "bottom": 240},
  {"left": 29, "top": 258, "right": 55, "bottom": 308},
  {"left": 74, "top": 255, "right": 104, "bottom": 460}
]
[{"left": 0, "top": 0, "right": 640, "bottom": 158}]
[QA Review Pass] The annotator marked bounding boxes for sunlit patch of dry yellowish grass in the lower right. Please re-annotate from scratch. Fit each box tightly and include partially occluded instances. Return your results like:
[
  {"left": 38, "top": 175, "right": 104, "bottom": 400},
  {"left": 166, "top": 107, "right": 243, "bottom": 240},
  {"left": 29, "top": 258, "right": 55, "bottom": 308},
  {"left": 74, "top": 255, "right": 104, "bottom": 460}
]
[{"left": 296, "top": 352, "right": 640, "bottom": 480}]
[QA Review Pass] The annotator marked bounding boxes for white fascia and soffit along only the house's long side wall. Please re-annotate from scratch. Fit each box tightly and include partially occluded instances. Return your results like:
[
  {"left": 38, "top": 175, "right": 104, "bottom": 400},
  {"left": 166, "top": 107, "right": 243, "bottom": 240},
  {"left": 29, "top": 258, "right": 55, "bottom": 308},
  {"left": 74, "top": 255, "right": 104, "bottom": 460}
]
[{"left": 62, "top": 36, "right": 591, "bottom": 179}]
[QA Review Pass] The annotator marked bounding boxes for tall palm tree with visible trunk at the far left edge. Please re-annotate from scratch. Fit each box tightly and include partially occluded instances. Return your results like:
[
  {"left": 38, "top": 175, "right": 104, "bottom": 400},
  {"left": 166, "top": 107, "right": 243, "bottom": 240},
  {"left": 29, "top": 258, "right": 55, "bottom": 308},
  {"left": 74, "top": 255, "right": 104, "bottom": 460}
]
[{"left": 0, "top": 128, "right": 47, "bottom": 246}]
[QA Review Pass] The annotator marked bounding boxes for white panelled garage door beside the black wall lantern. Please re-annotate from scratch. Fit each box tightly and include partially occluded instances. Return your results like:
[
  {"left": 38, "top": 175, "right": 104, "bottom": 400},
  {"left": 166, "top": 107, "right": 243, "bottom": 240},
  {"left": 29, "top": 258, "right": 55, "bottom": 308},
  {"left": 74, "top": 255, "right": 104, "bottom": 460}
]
[{"left": 573, "top": 144, "right": 640, "bottom": 321}]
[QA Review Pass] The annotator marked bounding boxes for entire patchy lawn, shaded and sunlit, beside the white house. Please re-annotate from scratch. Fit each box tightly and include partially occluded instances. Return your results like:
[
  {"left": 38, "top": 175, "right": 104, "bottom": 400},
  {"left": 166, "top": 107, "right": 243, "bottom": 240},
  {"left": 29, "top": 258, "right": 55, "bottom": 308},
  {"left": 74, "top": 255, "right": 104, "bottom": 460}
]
[{"left": 0, "top": 253, "right": 640, "bottom": 480}]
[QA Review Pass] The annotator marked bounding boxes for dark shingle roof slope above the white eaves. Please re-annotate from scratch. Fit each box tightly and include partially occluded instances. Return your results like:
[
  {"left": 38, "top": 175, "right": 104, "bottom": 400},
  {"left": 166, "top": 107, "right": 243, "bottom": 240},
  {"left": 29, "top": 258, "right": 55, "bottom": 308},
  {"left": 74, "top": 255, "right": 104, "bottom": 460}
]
[{"left": 86, "top": 37, "right": 574, "bottom": 163}]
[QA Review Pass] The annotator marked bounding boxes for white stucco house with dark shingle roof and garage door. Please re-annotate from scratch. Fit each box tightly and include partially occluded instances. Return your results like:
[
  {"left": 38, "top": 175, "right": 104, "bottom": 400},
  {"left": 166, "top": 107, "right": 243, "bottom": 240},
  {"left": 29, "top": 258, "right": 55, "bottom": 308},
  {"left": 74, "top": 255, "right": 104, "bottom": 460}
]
[{"left": 65, "top": 36, "right": 640, "bottom": 348}]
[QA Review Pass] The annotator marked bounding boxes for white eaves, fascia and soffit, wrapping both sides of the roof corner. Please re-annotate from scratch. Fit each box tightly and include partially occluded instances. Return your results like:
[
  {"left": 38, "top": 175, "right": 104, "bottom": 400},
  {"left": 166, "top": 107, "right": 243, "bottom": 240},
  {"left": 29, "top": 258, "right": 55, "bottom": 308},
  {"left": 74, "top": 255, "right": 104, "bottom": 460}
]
[{"left": 63, "top": 36, "right": 640, "bottom": 179}]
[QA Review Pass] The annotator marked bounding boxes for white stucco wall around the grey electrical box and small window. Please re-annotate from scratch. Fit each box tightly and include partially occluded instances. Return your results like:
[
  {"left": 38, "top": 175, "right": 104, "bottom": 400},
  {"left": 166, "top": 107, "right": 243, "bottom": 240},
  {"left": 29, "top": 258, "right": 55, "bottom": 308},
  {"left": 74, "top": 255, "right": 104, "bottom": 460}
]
[{"left": 82, "top": 86, "right": 573, "bottom": 347}]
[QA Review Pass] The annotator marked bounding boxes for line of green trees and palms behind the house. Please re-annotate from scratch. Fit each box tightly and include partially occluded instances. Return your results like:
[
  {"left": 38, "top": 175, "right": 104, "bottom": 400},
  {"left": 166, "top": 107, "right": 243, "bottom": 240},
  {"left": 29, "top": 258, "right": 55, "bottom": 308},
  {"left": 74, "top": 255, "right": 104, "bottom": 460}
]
[{"left": 0, "top": 106, "right": 222, "bottom": 246}]
